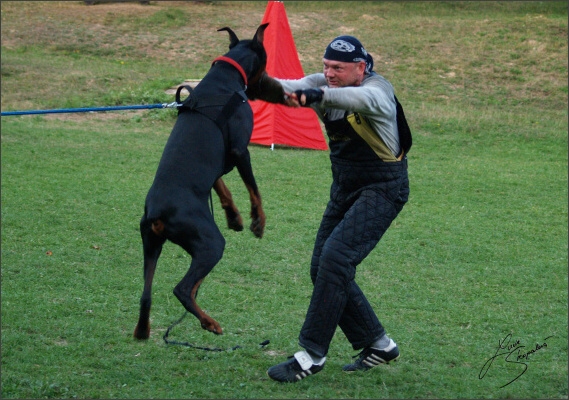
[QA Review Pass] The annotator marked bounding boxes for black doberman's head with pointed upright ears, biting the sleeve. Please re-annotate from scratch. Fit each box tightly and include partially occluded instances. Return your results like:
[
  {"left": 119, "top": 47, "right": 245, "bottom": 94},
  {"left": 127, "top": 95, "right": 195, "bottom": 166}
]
[{"left": 218, "top": 23, "right": 284, "bottom": 104}]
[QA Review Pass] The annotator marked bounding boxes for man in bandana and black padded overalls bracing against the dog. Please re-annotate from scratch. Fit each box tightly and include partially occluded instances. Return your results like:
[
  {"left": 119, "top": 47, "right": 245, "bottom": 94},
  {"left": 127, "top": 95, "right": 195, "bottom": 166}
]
[{"left": 267, "top": 36, "right": 410, "bottom": 382}]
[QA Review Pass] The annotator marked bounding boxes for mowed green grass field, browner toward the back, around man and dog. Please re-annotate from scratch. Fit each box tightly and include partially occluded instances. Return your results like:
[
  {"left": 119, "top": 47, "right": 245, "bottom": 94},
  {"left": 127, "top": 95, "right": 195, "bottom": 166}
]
[{"left": 1, "top": 2, "right": 568, "bottom": 398}]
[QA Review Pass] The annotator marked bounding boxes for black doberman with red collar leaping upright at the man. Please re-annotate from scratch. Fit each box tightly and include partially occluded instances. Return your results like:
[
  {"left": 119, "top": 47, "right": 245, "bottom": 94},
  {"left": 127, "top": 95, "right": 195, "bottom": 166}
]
[{"left": 134, "top": 24, "right": 285, "bottom": 339}]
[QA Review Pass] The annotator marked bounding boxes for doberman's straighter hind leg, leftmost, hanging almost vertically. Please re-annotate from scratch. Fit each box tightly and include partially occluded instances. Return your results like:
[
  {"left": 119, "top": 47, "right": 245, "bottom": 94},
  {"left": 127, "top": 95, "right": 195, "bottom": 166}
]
[{"left": 134, "top": 217, "right": 166, "bottom": 339}]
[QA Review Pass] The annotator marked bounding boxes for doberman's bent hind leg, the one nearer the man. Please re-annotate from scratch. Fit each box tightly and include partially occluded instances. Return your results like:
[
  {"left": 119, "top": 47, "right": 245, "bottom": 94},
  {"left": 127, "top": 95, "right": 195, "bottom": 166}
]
[{"left": 174, "top": 218, "right": 225, "bottom": 335}]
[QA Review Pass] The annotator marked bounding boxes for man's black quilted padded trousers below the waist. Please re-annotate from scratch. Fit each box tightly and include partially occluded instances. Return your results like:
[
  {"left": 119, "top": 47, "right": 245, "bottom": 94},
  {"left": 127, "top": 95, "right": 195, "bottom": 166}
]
[{"left": 299, "top": 158, "right": 409, "bottom": 357}]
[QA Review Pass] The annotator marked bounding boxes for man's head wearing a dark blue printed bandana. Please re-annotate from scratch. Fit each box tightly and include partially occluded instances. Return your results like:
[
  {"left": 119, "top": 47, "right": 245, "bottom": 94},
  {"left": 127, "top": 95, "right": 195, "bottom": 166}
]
[{"left": 322, "top": 36, "right": 373, "bottom": 87}]
